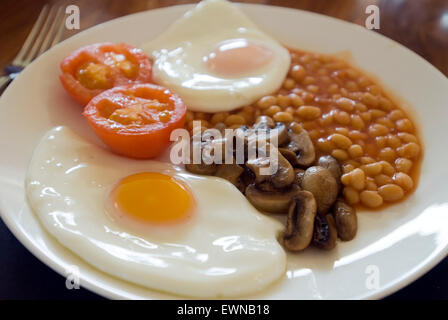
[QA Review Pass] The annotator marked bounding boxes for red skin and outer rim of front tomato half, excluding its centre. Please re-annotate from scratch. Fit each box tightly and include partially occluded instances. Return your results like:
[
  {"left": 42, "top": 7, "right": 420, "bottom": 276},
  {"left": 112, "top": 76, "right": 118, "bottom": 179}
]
[{"left": 83, "top": 83, "right": 186, "bottom": 159}]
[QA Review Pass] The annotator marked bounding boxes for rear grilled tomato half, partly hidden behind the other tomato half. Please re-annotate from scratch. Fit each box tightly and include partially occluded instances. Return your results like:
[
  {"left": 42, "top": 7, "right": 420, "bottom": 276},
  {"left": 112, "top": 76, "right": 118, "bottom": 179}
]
[{"left": 60, "top": 43, "right": 151, "bottom": 105}]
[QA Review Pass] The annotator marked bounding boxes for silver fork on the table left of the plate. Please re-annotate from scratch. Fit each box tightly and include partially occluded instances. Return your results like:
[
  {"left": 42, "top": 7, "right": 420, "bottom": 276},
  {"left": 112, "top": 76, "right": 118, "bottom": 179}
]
[{"left": 0, "top": 4, "right": 64, "bottom": 90}]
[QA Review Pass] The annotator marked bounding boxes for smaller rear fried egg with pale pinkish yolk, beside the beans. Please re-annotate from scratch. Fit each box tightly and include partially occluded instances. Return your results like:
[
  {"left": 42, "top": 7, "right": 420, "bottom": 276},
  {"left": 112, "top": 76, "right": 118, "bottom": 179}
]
[{"left": 142, "top": 0, "right": 291, "bottom": 112}]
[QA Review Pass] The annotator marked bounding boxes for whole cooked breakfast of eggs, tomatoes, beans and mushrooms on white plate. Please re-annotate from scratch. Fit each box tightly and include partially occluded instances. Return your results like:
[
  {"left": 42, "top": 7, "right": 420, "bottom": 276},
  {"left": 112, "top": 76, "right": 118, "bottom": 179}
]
[{"left": 26, "top": 0, "right": 422, "bottom": 298}]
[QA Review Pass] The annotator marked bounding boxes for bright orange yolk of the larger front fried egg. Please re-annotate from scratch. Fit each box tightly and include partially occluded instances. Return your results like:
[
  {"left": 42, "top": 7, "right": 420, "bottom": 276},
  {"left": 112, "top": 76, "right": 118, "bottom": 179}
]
[{"left": 112, "top": 172, "right": 194, "bottom": 224}]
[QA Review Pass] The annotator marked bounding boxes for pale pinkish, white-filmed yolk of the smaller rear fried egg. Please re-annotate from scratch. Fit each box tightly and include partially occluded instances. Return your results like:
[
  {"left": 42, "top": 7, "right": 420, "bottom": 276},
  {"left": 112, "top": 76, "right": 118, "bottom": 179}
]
[{"left": 204, "top": 39, "right": 274, "bottom": 77}]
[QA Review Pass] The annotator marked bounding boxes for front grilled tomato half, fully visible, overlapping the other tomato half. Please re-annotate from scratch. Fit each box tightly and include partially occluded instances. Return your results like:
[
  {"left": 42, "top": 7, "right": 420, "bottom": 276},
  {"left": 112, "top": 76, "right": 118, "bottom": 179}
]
[{"left": 83, "top": 83, "right": 186, "bottom": 159}]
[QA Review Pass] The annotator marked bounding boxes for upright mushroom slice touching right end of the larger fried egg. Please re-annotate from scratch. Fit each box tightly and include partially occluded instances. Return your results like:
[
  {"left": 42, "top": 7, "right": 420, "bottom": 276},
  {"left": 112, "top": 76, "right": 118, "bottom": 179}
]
[{"left": 283, "top": 191, "right": 316, "bottom": 251}]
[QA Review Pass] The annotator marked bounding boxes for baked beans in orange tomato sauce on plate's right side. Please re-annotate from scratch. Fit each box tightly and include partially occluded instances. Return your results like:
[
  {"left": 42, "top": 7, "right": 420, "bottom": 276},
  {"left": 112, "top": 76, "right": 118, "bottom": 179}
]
[{"left": 186, "top": 50, "right": 422, "bottom": 209}]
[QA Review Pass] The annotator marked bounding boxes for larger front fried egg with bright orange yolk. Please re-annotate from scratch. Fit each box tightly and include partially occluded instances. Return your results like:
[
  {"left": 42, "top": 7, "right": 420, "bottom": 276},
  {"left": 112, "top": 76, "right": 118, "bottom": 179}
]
[{"left": 26, "top": 127, "right": 286, "bottom": 298}]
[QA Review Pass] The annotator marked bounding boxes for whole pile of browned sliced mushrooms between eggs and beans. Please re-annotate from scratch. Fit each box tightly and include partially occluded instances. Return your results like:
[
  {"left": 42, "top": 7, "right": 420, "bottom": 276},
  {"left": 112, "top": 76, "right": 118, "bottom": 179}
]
[{"left": 185, "top": 116, "right": 358, "bottom": 251}]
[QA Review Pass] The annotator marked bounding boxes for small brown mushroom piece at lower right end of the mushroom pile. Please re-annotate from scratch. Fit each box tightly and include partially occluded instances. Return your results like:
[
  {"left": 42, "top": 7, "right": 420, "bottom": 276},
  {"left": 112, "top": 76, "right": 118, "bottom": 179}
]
[{"left": 333, "top": 199, "right": 358, "bottom": 241}]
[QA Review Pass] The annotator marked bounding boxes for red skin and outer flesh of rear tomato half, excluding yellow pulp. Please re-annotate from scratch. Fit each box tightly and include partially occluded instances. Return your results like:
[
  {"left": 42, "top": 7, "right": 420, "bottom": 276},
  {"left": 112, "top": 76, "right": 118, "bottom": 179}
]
[{"left": 59, "top": 42, "right": 152, "bottom": 106}]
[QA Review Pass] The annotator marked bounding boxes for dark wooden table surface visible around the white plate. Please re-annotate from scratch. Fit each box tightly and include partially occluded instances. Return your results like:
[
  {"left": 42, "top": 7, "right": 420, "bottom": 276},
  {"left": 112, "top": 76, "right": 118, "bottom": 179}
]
[{"left": 0, "top": 0, "right": 448, "bottom": 299}]
